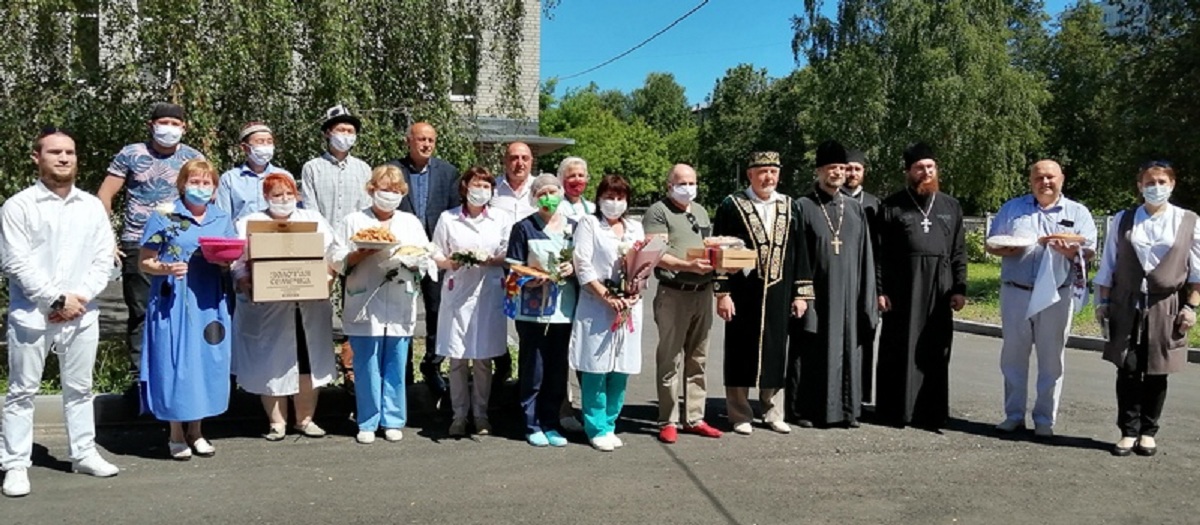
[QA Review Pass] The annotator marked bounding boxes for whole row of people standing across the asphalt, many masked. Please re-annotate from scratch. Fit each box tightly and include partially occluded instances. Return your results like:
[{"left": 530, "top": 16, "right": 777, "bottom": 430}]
[{"left": 0, "top": 103, "right": 1200, "bottom": 496}]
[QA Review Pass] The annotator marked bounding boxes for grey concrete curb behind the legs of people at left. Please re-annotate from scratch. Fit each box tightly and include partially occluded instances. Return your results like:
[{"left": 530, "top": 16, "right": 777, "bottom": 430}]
[{"left": 24, "top": 382, "right": 520, "bottom": 428}]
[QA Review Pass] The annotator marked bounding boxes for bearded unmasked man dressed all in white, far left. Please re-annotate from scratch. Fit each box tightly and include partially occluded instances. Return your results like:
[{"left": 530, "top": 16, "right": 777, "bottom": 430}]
[{"left": 0, "top": 128, "right": 119, "bottom": 497}]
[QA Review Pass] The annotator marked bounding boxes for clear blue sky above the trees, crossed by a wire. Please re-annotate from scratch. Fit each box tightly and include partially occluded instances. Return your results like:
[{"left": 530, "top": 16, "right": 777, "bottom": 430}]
[{"left": 541, "top": 0, "right": 1074, "bottom": 104}]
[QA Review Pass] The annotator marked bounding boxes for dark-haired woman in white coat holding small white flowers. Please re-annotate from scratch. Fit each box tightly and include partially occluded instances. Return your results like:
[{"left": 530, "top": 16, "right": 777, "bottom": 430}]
[{"left": 433, "top": 167, "right": 512, "bottom": 438}]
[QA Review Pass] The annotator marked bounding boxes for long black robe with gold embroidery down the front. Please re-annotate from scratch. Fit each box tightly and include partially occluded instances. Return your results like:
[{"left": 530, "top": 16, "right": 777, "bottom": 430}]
[{"left": 713, "top": 193, "right": 812, "bottom": 388}]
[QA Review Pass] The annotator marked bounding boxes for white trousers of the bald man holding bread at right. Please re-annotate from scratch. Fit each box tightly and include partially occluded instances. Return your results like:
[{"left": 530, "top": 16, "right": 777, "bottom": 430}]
[{"left": 1000, "top": 284, "right": 1074, "bottom": 427}]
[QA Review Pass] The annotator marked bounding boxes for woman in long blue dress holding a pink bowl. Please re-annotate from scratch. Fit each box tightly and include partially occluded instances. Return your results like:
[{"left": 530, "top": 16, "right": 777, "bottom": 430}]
[{"left": 138, "top": 158, "right": 235, "bottom": 460}]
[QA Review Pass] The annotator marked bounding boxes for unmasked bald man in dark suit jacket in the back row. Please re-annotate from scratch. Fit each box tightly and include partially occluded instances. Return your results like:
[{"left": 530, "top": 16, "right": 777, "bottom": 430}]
[{"left": 391, "top": 122, "right": 461, "bottom": 399}]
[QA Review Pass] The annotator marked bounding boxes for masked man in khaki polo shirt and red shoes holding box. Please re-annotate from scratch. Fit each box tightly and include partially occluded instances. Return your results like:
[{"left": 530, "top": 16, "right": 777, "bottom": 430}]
[{"left": 642, "top": 164, "right": 721, "bottom": 443}]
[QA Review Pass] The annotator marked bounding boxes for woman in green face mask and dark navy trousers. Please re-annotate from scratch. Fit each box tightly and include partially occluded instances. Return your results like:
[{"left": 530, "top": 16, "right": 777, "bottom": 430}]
[{"left": 505, "top": 174, "right": 578, "bottom": 447}]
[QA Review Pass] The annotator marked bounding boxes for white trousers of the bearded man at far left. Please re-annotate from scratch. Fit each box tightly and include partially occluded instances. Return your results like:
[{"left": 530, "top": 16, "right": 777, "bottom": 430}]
[{"left": 0, "top": 322, "right": 100, "bottom": 470}]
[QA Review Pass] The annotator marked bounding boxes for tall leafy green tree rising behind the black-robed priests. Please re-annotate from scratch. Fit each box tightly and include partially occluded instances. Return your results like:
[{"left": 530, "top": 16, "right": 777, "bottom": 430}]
[{"left": 793, "top": 0, "right": 1049, "bottom": 212}]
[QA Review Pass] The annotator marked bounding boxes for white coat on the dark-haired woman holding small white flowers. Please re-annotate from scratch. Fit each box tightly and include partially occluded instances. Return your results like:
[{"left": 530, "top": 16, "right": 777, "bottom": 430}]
[{"left": 433, "top": 207, "right": 512, "bottom": 360}]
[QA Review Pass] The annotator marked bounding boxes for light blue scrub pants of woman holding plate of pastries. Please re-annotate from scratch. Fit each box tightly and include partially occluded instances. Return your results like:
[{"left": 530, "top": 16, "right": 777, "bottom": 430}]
[{"left": 349, "top": 336, "right": 413, "bottom": 432}]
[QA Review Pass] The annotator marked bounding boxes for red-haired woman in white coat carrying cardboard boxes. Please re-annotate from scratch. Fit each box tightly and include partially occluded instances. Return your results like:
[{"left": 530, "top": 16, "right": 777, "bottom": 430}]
[{"left": 233, "top": 173, "right": 335, "bottom": 441}]
